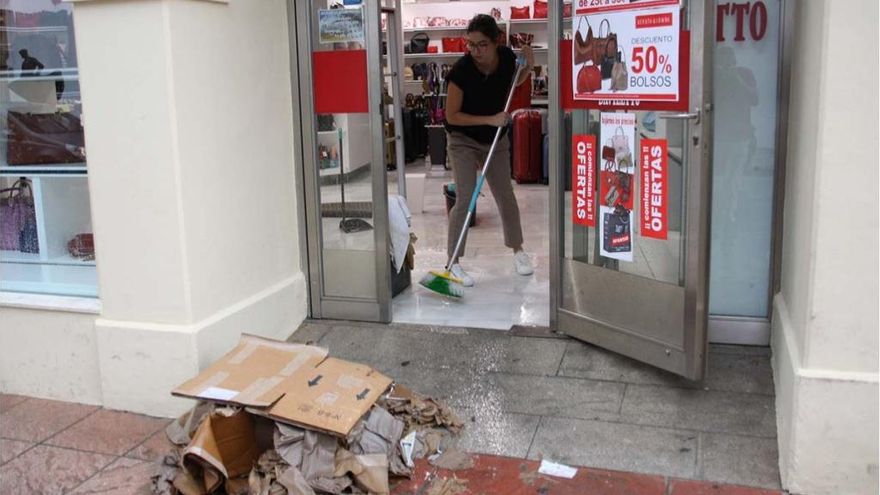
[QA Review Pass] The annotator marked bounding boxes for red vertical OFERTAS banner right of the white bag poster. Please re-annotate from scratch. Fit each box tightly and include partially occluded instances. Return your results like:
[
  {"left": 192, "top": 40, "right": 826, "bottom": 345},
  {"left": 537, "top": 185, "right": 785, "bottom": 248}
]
[{"left": 639, "top": 139, "right": 669, "bottom": 239}]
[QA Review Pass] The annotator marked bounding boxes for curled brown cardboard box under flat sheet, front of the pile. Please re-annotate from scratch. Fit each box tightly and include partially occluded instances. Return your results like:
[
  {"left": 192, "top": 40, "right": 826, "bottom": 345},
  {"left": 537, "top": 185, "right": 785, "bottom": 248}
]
[{"left": 175, "top": 409, "right": 260, "bottom": 493}]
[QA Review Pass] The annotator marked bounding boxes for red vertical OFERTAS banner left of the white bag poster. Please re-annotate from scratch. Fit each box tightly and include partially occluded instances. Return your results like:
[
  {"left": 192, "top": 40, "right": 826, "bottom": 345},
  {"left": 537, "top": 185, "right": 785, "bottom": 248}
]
[{"left": 571, "top": 134, "right": 596, "bottom": 227}]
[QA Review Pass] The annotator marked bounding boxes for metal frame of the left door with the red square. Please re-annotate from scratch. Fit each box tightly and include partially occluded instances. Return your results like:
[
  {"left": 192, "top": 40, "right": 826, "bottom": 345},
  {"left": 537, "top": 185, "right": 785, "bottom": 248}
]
[{"left": 287, "top": 0, "right": 391, "bottom": 322}]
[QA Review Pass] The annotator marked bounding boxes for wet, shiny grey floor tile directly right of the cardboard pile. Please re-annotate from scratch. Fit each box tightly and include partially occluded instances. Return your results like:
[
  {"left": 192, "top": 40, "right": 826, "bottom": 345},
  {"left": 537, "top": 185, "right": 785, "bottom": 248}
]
[{"left": 452, "top": 409, "right": 541, "bottom": 459}]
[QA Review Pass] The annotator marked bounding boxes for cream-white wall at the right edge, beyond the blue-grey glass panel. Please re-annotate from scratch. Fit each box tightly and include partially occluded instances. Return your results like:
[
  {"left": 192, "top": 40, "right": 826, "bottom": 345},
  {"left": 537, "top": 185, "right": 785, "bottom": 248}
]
[{"left": 773, "top": 0, "right": 878, "bottom": 494}]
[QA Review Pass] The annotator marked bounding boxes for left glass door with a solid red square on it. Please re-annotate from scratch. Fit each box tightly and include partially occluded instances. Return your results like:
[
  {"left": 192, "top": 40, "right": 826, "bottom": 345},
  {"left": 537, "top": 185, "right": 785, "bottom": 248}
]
[{"left": 288, "top": 0, "right": 391, "bottom": 322}]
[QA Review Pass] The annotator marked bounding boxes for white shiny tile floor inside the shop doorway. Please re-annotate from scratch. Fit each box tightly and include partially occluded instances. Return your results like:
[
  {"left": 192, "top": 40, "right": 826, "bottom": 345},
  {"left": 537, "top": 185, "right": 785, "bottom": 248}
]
[{"left": 389, "top": 167, "right": 550, "bottom": 330}]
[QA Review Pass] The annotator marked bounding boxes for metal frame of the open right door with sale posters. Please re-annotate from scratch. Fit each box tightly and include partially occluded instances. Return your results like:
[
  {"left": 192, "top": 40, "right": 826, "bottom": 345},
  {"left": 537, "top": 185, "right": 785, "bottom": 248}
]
[{"left": 548, "top": 0, "right": 715, "bottom": 380}]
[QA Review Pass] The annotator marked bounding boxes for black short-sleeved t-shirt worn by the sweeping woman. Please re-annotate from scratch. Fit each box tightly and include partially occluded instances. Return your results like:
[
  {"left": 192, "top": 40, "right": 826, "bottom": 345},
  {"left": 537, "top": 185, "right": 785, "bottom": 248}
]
[{"left": 446, "top": 46, "right": 516, "bottom": 144}]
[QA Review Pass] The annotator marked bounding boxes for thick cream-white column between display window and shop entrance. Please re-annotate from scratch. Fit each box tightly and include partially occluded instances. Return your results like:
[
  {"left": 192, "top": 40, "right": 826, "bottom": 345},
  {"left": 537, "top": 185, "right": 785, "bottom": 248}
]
[{"left": 74, "top": 0, "right": 307, "bottom": 415}]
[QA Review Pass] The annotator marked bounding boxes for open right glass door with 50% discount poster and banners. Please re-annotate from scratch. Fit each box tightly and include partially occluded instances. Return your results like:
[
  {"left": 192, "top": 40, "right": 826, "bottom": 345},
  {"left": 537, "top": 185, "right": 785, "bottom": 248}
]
[{"left": 549, "top": 0, "right": 714, "bottom": 380}]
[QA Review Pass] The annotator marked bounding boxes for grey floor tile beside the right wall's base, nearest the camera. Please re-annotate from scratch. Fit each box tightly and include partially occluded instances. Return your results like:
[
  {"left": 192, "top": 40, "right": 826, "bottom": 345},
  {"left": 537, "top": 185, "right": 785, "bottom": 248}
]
[{"left": 699, "top": 433, "right": 780, "bottom": 489}]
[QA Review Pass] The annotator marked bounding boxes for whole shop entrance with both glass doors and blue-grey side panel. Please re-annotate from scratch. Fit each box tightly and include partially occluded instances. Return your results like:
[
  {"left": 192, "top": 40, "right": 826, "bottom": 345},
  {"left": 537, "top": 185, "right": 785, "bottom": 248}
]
[{"left": 295, "top": 0, "right": 784, "bottom": 377}]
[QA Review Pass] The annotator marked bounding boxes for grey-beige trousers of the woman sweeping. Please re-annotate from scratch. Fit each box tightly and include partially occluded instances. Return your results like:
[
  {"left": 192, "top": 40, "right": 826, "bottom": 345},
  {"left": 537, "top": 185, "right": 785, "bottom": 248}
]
[{"left": 446, "top": 132, "right": 523, "bottom": 263}]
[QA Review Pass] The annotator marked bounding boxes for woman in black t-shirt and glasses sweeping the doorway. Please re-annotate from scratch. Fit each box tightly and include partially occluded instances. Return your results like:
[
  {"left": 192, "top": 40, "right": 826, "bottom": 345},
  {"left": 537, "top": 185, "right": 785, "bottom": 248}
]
[{"left": 446, "top": 14, "right": 534, "bottom": 287}]
